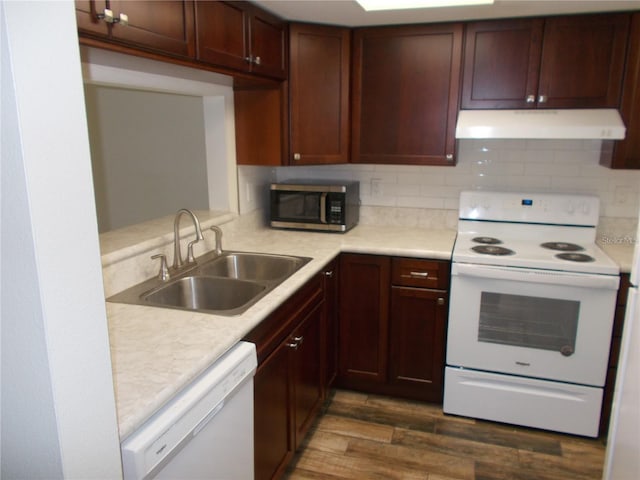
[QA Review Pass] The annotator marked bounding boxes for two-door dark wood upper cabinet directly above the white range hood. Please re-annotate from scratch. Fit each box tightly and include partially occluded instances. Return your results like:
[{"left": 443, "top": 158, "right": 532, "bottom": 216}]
[{"left": 461, "top": 14, "right": 629, "bottom": 109}]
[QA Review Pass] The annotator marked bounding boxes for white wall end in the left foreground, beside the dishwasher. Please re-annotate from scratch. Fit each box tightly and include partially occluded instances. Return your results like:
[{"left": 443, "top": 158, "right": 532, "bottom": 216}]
[{"left": 0, "top": 1, "right": 121, "bottom": 479}]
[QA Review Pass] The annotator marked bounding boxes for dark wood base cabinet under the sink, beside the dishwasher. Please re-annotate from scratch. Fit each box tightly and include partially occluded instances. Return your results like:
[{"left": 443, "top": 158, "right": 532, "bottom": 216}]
[{"left": 244, "top": 274, "right": 324, "bottom": 480}]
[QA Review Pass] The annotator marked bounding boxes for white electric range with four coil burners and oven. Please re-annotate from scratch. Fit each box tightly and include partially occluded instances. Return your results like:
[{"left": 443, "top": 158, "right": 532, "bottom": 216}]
[{"left": 443, "top": 191, "right": 619, "bottom": 437}]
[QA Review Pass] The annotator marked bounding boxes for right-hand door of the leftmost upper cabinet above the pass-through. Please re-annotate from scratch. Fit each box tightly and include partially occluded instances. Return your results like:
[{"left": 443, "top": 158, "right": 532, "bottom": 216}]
[{"left": 110, "top": 0, "right": 195, "bottom": 57}]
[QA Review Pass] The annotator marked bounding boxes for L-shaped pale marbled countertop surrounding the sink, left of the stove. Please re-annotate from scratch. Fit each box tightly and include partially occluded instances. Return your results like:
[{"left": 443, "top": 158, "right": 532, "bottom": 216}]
[{"left": 107, "top": 225, "right": 456, "bottom": 439}]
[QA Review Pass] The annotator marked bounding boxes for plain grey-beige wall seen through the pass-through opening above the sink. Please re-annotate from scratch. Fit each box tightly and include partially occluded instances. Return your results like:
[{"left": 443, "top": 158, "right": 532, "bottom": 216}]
[{"left": 85, "top": 84, "right": 209, "bottom": 232}]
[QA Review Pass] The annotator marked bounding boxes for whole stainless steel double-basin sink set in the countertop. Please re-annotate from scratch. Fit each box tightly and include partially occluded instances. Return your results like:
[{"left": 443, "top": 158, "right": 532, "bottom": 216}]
[{"left": 107, "top": 251, "right": 311, "bottom": 315}]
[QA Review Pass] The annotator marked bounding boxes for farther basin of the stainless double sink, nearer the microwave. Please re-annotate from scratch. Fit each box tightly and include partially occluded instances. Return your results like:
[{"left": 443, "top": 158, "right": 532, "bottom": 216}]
[{"left": 198, "top": 252, "right": 309, "bottom": 282}]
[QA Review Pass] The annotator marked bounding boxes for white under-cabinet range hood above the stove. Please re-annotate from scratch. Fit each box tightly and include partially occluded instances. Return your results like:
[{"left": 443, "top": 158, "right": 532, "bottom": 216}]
[{"left": 456, "top": 108, "right": 626, "bottom": 140}]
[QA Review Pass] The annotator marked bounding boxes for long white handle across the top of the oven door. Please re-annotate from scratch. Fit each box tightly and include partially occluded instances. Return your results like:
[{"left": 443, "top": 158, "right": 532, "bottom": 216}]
[{"left": 451, "top": 263, "right": 620, "bottom": 290}]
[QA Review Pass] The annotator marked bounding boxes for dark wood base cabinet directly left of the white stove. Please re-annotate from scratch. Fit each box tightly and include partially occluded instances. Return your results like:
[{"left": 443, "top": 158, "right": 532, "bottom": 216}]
[{"left": 337, "top": 254, "right": 449, "bottom": 403}]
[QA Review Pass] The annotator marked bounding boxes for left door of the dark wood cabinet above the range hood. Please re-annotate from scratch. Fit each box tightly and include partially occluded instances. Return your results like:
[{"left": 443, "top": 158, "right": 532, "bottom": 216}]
[{"left": 461, "top": 19, "right": 543, "bottom": 109}]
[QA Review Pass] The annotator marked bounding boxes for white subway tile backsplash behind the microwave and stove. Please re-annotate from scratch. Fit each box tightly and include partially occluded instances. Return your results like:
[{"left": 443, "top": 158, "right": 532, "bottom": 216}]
[{"left": 238, "top": 140, "right": 640, "bottom": 226}]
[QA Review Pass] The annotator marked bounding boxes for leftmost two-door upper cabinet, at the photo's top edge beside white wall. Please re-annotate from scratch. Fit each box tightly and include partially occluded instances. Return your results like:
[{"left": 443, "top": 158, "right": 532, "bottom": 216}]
[{"left": 76, "top": 0, "right": 195, "bottom": 57}]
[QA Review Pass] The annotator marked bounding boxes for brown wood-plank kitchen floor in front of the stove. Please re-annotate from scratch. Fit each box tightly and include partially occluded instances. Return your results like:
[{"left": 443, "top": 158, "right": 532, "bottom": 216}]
[{"left": 286, "top": 391, "right": 605, "bottom": 480}]
